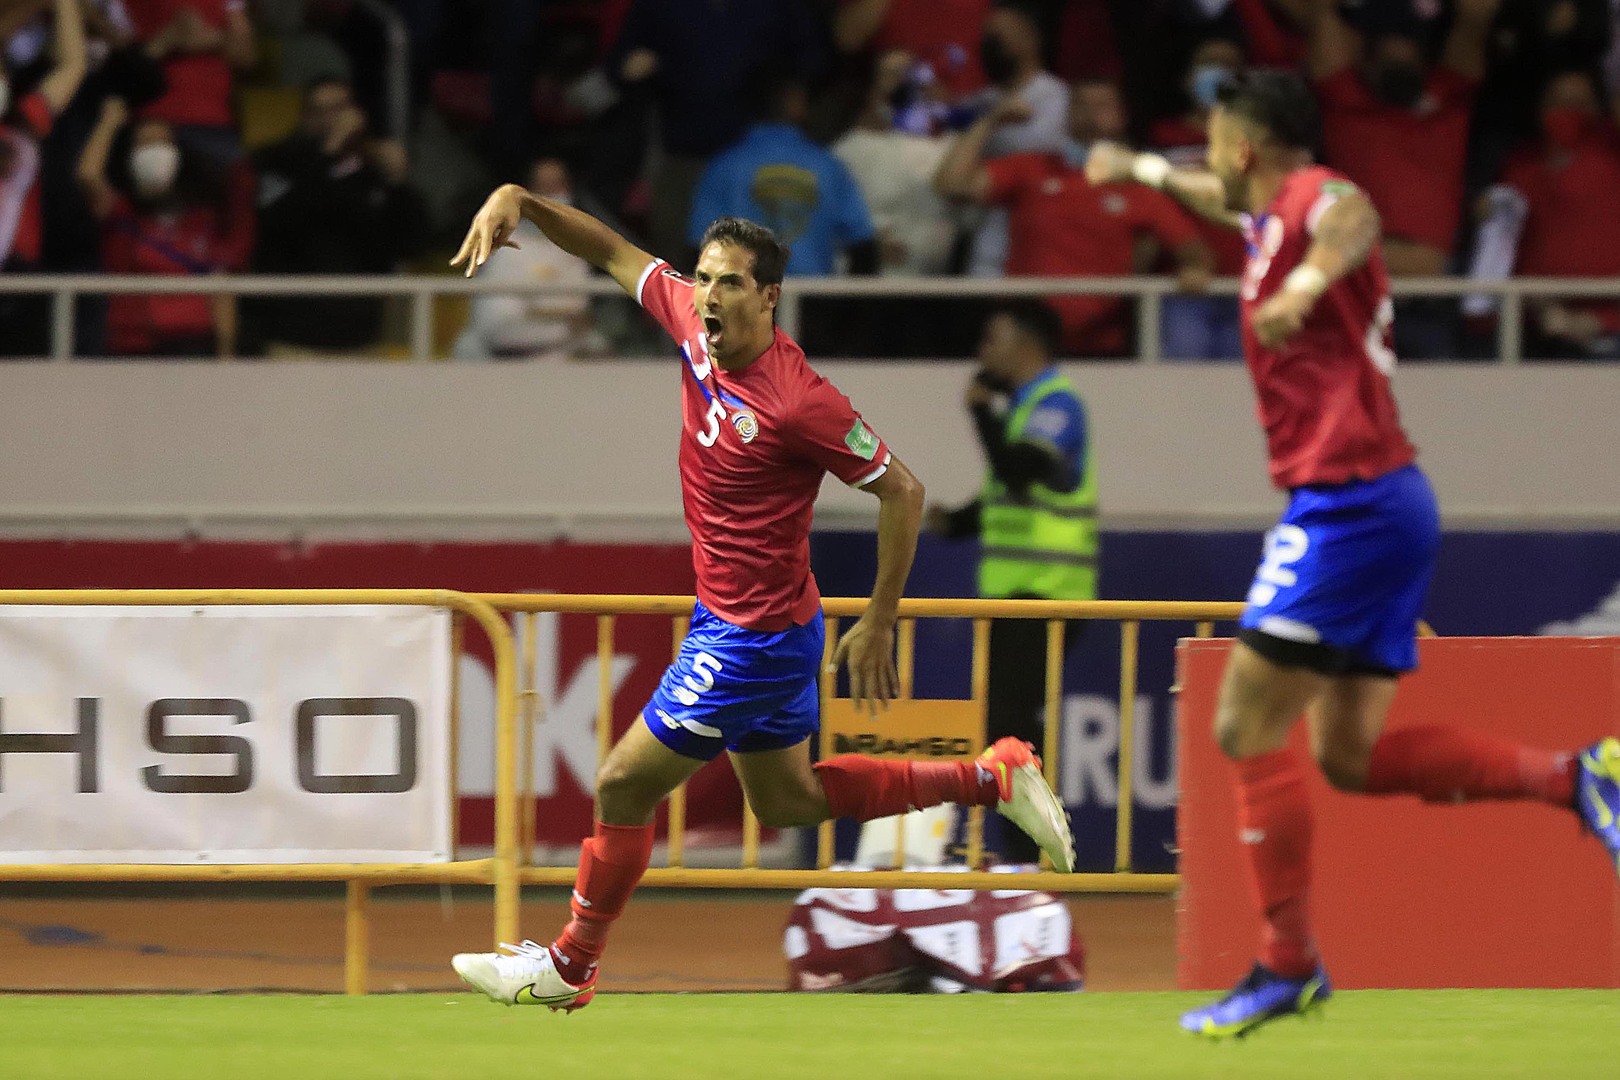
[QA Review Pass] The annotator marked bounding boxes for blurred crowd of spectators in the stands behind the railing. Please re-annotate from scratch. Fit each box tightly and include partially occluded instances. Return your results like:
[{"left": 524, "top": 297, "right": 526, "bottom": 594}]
[{"left": 0, "top": 0, "right": 1620, "bottom": 361}]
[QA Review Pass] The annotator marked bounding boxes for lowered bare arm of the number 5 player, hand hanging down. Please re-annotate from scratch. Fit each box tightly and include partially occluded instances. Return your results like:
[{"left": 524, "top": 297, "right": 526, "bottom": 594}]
[{"left": 833, "top": 455, "right": 925, "bottom": 711}]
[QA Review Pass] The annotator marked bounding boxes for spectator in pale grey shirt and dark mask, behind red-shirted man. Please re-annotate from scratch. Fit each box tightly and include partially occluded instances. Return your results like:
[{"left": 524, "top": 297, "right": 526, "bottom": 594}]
[{"left": 967, "top": 0, "right": 1069, "bottom": 277}]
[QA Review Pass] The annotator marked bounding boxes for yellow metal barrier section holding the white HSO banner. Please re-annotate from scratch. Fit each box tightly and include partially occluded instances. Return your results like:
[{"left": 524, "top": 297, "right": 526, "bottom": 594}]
[{"left": 0, "top": 589, "right": 518, "bottom": 994}]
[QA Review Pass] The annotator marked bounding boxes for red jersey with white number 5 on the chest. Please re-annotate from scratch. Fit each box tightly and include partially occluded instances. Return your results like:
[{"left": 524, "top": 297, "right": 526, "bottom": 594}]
[{"left": 635, "top": 261, "right": 889, "bottom": 630}]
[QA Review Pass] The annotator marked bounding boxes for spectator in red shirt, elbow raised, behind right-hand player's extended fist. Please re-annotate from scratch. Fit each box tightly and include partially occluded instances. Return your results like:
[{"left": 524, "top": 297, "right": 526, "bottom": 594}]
[{"left": 935, "top": 81, "right": 1213, "bottom": 356}]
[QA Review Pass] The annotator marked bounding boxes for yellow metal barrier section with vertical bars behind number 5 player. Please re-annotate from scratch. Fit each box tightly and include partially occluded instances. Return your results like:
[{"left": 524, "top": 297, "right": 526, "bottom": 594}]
[{"left": 478, "top": 593, "right": 1243, "bottom": 892}]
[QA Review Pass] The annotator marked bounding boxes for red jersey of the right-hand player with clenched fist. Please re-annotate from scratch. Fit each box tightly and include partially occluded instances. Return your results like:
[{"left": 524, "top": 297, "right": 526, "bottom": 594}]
[{"left": 1241, "top": 165, "right": 1418, "bottom": 487}]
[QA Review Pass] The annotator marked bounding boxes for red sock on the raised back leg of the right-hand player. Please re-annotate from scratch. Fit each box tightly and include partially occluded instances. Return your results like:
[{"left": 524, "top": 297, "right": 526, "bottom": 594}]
[{"left": 1367, "top": 724, "right": 1576, "bottom": 806}]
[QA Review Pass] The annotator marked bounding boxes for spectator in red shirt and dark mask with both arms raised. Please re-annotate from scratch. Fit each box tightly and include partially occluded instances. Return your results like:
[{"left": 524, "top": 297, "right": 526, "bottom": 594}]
[{"left": 1311, "top": 0, "right": 1500, "bottom": 356}]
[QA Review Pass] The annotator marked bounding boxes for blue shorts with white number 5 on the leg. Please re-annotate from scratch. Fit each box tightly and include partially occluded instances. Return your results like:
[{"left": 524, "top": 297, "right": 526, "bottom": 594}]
[{"left": 642, "top": 602, "right": 826, "bottom": 761}]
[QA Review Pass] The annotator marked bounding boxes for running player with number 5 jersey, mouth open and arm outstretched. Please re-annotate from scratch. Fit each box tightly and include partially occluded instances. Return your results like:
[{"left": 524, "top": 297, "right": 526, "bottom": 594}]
[{"left": 452, "top": 185, "right": 1074, "bottom": 1010}]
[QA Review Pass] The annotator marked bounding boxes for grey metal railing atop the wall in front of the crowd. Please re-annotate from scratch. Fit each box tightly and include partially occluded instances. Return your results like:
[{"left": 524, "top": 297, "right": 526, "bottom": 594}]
[{"left": 0, "top": 274, "right": 1600, "bottom": 364}]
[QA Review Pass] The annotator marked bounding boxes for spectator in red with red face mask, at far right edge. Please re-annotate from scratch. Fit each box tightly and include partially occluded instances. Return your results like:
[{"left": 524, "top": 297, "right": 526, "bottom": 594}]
[{"left": 1474, "top": 70, "right": 1620, "bottom": 359}]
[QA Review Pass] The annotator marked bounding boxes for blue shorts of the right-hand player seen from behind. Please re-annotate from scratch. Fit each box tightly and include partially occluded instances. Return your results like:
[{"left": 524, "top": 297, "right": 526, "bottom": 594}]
[{"left": 1243, "top": 465, "right": 1440, "bottom": 675}]
